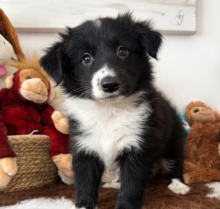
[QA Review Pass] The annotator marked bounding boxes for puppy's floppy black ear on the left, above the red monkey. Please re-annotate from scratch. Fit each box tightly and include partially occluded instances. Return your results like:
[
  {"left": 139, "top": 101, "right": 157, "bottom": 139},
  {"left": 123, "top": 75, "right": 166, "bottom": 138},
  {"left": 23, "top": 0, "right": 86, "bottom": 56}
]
[{"left": 40, "top": 42, "right": 64, "bottom": 84}]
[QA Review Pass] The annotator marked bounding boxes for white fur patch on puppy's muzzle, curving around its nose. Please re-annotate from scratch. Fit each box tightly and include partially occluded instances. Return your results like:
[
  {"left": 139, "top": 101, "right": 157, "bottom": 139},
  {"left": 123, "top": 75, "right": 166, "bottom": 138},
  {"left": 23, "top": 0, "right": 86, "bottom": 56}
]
[{"left": 92, "top": 65, "right": 116, "bottom": 99}]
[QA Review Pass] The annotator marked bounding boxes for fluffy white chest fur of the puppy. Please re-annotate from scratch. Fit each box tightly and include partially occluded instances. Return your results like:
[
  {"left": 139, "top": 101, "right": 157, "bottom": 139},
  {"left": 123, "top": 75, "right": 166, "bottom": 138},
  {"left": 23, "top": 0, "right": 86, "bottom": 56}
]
[{"left": 65, "top": 98, "right": 150, "bottom": 169}]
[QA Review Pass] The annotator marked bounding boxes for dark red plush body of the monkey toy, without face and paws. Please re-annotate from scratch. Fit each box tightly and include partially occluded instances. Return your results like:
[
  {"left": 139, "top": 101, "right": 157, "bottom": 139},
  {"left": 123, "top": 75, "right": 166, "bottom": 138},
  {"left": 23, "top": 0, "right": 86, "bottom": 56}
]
[{"left": 0, "top": 73, "right": 69, "bottom": 158}]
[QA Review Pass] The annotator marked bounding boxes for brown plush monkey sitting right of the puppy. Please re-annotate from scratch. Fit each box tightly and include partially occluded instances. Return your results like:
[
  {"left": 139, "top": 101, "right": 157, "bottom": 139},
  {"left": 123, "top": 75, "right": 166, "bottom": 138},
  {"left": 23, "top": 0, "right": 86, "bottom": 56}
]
[{"left": 184, "top": 101, "right": 220, "bottom": 184}]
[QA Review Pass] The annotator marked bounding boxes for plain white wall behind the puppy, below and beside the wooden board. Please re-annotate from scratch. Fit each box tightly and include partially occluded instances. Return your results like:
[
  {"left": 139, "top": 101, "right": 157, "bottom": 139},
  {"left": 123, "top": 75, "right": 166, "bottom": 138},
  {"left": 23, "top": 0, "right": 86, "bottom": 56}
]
[{"left": 15, "top": 0, "right": 220, "bottom": 111}]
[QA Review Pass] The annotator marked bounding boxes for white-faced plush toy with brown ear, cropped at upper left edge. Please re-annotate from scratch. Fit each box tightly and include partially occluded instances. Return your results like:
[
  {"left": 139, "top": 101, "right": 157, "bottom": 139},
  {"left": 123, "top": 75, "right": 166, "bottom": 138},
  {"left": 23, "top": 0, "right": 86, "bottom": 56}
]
[{"left": 0, "top": 9, "right": 24, "bottom": 88}]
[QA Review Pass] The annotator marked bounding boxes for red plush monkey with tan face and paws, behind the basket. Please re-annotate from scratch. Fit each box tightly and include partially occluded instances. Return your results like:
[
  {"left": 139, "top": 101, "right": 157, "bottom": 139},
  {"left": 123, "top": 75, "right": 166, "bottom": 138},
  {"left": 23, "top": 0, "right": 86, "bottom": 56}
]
[{"left": 0, "top": 57, "right": 73, "bottom": 187}]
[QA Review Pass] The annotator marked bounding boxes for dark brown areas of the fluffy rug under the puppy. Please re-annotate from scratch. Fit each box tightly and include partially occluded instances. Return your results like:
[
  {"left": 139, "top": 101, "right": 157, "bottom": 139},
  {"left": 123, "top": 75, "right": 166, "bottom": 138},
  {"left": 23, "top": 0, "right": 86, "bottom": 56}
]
[{"left": 0, "top": 179, "right": 220, "bottom": 209}]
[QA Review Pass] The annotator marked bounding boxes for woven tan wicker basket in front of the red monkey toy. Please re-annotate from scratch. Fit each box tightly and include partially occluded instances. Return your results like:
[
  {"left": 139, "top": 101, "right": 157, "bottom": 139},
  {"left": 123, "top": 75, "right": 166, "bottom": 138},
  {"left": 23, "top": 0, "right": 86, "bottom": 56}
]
[{"left": 0, "top": 135, "right": 58, "bottom": 192}]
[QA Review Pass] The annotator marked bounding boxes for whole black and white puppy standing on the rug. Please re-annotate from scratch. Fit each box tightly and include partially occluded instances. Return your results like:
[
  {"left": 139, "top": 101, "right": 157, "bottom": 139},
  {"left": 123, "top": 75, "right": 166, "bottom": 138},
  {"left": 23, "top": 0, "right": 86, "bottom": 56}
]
[{"left": 41, "top": 14, "right": 189, "bottom": 209}]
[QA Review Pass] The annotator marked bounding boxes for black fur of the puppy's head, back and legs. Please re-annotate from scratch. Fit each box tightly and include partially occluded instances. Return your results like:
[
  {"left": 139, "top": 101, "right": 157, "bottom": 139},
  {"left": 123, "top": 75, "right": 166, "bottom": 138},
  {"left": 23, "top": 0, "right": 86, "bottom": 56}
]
[{"left": 41, "top": 14, "right": 185, "bottom": 209}]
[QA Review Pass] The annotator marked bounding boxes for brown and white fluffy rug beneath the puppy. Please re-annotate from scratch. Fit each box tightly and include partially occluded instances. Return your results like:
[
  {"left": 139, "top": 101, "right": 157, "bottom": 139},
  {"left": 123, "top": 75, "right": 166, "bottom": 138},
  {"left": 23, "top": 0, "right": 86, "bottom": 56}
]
[{"left": 0, "top": 179, "right": 220, "bottom": 209}]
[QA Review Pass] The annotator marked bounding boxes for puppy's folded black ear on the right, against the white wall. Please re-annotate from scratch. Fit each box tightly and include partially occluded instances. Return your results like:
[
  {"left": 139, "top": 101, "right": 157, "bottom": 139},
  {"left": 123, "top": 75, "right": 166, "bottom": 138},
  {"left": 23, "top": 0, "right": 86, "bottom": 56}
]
[{"left": 136, "top": 22, "right": 162, "bottom": 59}]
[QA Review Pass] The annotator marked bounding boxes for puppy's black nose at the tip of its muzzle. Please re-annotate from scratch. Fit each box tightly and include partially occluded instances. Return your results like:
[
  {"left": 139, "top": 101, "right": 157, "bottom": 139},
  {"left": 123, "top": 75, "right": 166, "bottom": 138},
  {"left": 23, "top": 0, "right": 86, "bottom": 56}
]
[{"left": 101, "top": 76, "right": 120, "bottom": 93}]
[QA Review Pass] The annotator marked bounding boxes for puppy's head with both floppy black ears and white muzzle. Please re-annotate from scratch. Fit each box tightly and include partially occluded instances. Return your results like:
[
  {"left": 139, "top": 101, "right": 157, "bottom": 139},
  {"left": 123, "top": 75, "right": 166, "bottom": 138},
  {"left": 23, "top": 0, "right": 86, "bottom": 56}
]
[{"left": 41, "top": 14, "right": 162, "bottom": 100}]
